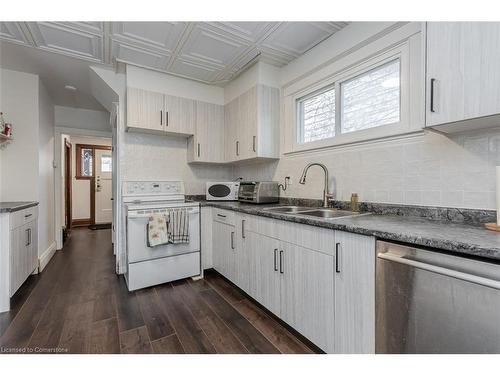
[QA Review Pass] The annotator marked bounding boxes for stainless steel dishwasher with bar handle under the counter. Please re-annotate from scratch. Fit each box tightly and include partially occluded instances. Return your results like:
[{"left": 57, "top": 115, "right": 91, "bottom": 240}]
[{"left": 375, "top": 241, "right": 500, "bottom": 353}]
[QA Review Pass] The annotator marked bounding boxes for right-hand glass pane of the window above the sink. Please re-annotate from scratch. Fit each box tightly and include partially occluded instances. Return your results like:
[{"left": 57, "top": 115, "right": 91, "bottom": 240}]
[{"left": 341, "top": 59, "right": 401, "bottom": 133}]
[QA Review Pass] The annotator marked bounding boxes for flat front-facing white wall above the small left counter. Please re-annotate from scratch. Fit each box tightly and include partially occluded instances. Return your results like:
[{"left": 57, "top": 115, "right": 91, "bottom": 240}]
[{"left": 0, "top": 69, "right": 39, "bottom": 201}]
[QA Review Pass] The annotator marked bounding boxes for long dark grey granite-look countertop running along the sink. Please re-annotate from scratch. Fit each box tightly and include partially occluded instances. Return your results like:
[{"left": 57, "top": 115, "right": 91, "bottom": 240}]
[{"left": 200, "top": 201, "right": 500, "bottom": 260}]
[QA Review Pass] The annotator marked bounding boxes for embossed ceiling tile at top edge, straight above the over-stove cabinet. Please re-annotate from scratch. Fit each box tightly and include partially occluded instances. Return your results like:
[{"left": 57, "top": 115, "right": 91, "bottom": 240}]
[{"left": 111, "top": 22, "right": 188, "bottom": 53}]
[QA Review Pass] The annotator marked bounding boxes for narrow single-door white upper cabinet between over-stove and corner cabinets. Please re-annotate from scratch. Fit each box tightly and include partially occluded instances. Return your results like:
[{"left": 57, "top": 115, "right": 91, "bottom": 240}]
[{"left": 188, "top": 101, "right": 225, "bottom": 163}]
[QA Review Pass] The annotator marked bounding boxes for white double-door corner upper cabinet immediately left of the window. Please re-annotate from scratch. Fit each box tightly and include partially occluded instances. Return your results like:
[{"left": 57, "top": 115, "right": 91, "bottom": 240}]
[{"left": 224, "top": 85, "right": 280, "bottom": 162}]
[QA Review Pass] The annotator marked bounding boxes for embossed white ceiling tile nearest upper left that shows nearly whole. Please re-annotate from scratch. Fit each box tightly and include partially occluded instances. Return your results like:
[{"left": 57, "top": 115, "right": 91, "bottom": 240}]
[{"left": 28, "top": 22, "right": 103, "bottom": 61}]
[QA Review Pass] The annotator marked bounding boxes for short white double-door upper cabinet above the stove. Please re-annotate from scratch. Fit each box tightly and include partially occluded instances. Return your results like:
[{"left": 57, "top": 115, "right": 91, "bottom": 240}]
[{"left": 127, "top": 87, "right": 196, "bottom": 136}]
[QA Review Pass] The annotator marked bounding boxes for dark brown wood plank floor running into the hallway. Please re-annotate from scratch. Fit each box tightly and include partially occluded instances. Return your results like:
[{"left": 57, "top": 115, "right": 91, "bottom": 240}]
[{"left": 0, "top": 229, "right": 314, "bottom": 354}]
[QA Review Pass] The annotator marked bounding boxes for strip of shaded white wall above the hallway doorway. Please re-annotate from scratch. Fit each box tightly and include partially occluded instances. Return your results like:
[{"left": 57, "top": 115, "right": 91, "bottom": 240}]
[{"left": 54, "top": 105, "right": 111, "bottom": 132}]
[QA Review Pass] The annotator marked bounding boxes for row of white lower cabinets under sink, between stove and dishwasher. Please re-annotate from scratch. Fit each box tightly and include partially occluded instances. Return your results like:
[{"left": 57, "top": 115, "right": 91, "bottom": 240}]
[{"left": 212, "top": 209, "right": 375, "bottom": 353}]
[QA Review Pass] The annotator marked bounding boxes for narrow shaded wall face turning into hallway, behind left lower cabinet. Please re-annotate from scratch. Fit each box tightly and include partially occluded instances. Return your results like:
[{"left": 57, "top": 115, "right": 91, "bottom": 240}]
[{"left": 38, "top": 82, "right": 55, "bottom": 255}]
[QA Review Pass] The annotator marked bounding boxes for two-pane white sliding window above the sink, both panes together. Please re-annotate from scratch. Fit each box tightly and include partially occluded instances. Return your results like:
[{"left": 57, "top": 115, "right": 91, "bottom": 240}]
[{"left": 296, "top": 55, "right": 402, "bottom": 146}]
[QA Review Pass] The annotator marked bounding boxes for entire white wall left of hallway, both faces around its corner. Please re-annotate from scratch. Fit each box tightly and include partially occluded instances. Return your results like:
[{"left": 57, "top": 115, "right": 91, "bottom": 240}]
[{"left": 0, "top": 69, "right": 55, "bottom": 264}]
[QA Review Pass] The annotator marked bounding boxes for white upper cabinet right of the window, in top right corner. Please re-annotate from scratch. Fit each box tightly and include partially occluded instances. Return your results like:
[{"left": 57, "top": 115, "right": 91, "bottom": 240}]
[{"left": 426, "top": 22, "right": 500, "bottom": 132}]
